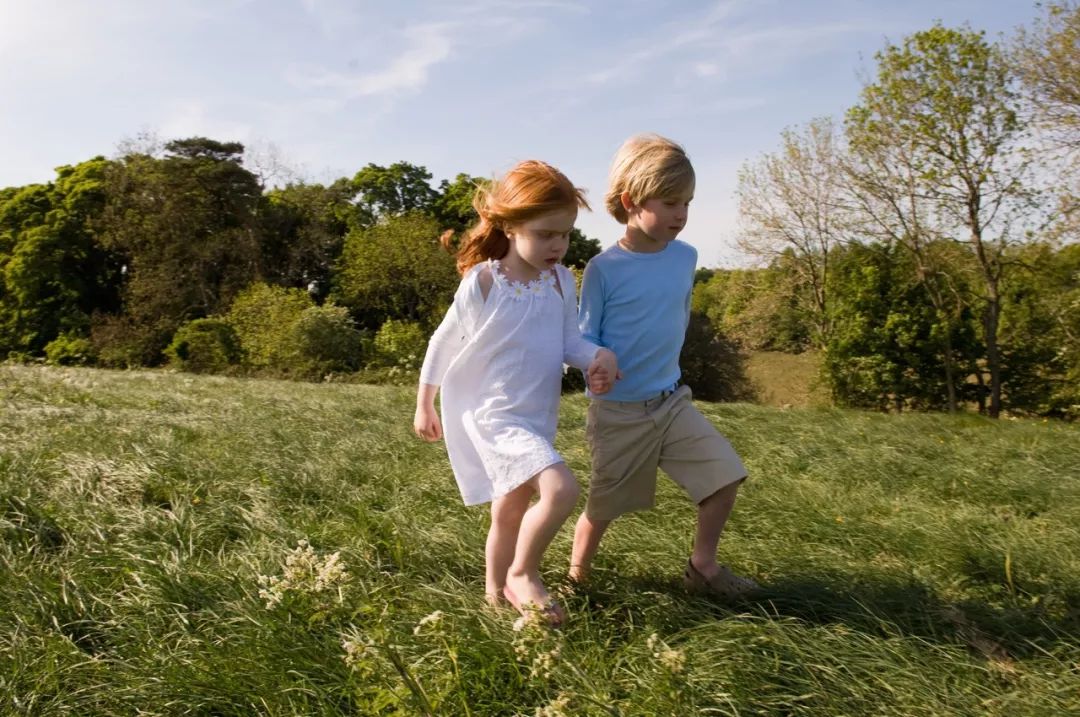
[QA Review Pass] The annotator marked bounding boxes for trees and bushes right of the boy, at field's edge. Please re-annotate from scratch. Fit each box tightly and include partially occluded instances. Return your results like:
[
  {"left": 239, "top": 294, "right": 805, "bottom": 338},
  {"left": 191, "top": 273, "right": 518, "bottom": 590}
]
[{"left": 697, "top": 2, "right": 1080, "bottom": 418}]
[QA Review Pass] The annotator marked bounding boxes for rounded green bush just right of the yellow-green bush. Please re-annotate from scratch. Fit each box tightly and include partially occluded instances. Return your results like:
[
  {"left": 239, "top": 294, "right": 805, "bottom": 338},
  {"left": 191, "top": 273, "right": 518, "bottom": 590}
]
[{"left": 283, "top": 303, "right": 362, "bottom": 378}]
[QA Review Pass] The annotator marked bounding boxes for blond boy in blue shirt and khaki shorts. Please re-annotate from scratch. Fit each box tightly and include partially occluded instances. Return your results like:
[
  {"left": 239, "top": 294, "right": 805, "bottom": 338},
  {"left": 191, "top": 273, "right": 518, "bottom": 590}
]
[{"left": 570, "top": 135, "right": 758, "bottom": 598}]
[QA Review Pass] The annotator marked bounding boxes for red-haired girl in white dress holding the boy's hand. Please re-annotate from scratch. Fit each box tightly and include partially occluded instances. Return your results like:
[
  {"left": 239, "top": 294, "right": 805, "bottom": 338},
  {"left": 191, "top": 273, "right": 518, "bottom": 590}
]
[{"left": 413, "top": 161, "right": 618, "bottom": 625}]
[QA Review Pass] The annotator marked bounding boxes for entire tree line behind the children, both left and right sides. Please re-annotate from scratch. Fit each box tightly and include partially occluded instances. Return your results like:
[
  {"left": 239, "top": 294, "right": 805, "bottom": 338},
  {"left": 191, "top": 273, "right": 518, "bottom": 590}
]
[{"left": 0, "top": 5, "right": 1080, "bottom": 418}]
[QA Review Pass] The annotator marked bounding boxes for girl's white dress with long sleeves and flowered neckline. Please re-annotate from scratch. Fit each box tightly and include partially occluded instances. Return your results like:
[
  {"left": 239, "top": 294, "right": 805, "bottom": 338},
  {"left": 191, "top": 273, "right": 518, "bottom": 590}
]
[{"left": 420, "top": 259, "right": 599, "bottom": 505}]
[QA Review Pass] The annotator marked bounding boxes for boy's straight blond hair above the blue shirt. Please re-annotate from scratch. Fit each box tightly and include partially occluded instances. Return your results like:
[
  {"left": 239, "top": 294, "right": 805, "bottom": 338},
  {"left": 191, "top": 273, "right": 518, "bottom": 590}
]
[{"left": 604, "top": 134, "right": 694, "bottom": 224}]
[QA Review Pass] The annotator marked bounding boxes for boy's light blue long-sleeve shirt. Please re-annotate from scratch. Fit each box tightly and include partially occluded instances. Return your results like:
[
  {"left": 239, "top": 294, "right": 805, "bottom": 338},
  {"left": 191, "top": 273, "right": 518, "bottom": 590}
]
[{"left": 578, "top": 240, "right": 698, "bottom": 401}]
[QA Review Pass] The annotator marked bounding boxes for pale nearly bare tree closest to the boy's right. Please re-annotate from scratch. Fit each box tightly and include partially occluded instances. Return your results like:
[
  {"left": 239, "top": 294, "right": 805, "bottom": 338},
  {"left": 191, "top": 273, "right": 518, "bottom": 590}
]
[{"left": 737, "top": 118, "right": 848, "bottom": 347}]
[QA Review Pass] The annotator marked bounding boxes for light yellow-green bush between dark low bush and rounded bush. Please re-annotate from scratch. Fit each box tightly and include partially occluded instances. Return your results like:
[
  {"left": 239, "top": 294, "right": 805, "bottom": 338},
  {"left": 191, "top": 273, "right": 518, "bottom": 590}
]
[{"left": 226, "top": 283, "right": 315, "bottom": 371}]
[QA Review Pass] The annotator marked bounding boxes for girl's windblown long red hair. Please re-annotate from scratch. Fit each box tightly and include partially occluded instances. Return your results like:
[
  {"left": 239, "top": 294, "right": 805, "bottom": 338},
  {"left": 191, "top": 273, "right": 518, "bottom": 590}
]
[{"left": 442, "top": 160, "right": 589, "bottom": 274}]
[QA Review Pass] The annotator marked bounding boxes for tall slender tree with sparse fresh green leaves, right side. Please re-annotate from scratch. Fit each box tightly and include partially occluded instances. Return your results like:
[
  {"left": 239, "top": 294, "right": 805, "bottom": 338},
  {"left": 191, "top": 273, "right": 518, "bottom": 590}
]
[{"left": 848, "top": 25, "right": 1030, "bottom": 417}]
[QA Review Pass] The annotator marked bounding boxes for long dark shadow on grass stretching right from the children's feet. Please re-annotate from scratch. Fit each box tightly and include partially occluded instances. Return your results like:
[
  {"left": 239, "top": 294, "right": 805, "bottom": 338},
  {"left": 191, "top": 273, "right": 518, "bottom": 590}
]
[{"left": 576, "top": 574, "right": 1080, "bottom": 661}]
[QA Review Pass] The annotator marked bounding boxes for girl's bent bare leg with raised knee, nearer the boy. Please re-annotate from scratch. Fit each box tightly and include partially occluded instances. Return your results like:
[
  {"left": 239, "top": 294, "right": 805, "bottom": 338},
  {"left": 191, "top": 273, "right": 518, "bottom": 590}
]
[{"left": 507, "top": 463, "right": 581, "bottom": 606}]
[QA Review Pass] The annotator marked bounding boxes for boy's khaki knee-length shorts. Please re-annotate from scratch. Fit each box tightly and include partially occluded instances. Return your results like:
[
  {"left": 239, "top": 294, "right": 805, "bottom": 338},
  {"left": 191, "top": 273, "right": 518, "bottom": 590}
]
[{"left": 585, "top": 385, "right": 746, "bottom": 520}]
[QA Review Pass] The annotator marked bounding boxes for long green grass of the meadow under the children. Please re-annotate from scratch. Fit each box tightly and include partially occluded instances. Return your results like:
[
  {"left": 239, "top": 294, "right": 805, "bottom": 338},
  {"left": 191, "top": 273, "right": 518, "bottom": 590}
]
[{"left": 0, "top": 366, "right": 1080, "bottom": 716}]
